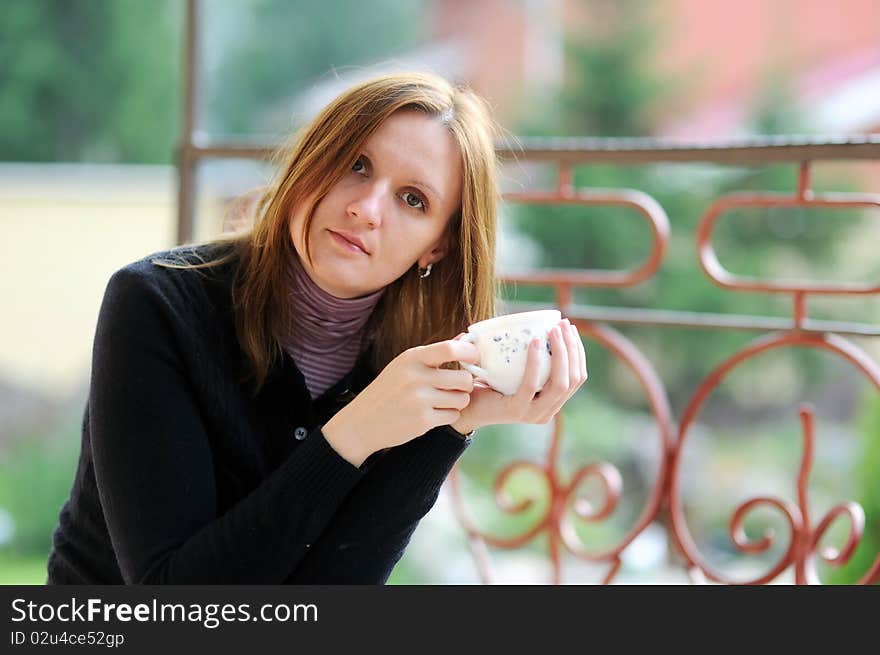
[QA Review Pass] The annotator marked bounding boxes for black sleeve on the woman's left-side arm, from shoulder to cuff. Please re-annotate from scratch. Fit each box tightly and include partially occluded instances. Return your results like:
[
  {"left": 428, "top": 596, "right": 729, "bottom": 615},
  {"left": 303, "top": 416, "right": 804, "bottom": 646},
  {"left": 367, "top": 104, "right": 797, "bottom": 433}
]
[{"left": 89, "top": 269, "right": 363, "bottom": 584}]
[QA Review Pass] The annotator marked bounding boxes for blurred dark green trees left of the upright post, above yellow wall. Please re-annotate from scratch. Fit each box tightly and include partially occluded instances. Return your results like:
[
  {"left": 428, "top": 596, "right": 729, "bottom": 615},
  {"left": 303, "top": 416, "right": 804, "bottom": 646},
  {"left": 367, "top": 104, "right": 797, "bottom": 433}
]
[{"left": 0, "top": 0, "right": 182, "bottom": 163}]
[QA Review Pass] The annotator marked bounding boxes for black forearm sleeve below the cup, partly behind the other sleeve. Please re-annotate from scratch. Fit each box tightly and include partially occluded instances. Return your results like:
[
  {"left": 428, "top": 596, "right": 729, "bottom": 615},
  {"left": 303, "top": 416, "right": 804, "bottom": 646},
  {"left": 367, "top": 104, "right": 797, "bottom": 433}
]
[{"left": 287, "top": 426, "right": 470, "bottom": 584}]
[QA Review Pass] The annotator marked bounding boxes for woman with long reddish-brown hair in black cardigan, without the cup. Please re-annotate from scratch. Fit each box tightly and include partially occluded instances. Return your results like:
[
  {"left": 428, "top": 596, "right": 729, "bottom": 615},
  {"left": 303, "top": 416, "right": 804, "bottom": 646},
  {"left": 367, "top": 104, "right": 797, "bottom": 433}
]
[{"left": 48, "top": 74, "right": 586, "bottom": 584}]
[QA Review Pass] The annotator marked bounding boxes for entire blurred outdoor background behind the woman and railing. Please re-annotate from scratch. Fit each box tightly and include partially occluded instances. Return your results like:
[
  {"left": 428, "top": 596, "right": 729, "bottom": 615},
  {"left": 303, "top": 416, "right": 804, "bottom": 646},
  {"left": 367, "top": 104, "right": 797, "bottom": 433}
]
[{"left": 0, "top": 0, "right": 880, "bottom": 584}]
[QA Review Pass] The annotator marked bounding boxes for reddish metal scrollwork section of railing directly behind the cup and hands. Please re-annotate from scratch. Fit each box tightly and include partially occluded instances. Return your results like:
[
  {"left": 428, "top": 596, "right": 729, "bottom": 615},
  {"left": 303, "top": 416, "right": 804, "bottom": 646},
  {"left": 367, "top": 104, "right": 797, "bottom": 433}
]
[{"left": 449, "top": 165, "right": 672, "bottom": 584}]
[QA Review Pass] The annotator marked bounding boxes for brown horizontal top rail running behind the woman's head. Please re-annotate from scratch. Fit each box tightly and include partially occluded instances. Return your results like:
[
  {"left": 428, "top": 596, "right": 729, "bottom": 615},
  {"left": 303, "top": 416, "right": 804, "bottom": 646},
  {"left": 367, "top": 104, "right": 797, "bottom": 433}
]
[{"left": 185, "top": 135, "right": 880, "bottom": 164}]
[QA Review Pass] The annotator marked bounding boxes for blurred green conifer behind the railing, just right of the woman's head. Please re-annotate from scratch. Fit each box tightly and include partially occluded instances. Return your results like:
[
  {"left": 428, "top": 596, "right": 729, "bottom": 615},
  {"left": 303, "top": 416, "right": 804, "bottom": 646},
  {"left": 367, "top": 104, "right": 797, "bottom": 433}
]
[{"left": 514, "top": 0, "right": 718, "bottom": 410}]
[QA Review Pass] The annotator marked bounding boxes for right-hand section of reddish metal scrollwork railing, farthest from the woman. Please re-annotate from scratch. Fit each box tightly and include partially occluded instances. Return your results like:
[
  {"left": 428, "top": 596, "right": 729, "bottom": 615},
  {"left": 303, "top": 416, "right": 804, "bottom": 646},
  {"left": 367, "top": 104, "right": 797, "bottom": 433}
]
[{"left": 669, "top": 162, "right": 880, "bottom": 584}]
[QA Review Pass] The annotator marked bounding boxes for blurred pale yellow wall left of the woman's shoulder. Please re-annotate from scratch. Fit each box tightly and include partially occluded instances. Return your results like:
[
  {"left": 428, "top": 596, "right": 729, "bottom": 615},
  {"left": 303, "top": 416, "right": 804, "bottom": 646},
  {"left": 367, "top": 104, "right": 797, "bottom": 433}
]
[{"left": 0, "top": 164, "right": 223, "bottom": 397}]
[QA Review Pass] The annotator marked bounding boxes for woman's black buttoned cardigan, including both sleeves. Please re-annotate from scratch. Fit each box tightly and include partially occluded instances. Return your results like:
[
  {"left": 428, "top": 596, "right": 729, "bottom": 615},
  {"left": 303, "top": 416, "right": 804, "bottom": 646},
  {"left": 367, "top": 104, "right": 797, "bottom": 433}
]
[{"left": 47, "top": 247, "right": 470, "bottom": 584}]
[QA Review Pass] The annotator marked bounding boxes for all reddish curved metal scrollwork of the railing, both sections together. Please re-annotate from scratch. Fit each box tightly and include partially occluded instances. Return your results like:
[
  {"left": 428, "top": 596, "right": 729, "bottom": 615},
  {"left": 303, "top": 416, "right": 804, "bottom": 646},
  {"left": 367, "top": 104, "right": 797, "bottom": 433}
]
[{"left": 449, "top": 153, "right": 880, "bottom": 584}]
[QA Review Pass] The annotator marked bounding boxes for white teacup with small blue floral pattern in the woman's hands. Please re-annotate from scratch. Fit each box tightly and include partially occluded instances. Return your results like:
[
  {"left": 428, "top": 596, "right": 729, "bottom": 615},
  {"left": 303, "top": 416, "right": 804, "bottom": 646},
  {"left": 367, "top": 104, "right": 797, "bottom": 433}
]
[{"left": 459, "top": 309, "right": 562, "bottom": 396}]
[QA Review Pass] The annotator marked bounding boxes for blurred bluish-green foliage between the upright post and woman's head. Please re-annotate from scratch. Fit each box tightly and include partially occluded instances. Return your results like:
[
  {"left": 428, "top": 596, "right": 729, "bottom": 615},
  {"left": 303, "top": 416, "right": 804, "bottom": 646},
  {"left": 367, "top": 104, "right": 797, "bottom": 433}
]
[{"left": 204, "top": 0, "right": 428, "bottom": 134}]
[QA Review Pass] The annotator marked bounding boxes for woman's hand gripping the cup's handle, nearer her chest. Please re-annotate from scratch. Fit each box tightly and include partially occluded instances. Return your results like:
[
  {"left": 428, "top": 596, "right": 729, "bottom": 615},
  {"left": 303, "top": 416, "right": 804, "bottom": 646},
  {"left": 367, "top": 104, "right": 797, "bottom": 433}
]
[{"left": 322, "top": 340, "right": 479, "bottom": 466}]
